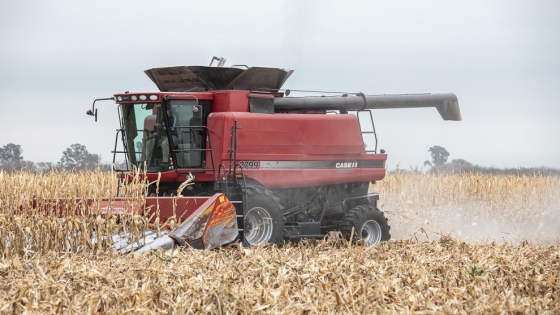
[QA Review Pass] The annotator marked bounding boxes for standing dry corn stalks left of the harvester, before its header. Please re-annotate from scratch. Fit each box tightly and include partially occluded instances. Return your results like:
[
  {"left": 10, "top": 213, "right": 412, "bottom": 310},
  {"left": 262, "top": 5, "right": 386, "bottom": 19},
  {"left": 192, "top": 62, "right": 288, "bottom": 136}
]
[{"left": 0, "top": 172, "right": 148, "bottom": 257}]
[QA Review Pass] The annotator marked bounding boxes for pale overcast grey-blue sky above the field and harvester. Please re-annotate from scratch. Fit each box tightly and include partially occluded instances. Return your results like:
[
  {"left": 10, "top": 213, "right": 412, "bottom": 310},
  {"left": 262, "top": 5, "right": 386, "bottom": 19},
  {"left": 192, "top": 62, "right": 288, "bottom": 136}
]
[{"left": 0, "top": 0, "right": 560, "bottom": 169}]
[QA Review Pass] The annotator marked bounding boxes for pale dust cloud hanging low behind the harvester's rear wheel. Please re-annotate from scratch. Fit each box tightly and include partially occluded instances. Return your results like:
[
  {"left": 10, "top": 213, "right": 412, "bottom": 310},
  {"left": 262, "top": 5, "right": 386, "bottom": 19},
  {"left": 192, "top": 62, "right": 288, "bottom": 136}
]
[{"left": 378, "top": 180, "right": 560, "bottom": 246}]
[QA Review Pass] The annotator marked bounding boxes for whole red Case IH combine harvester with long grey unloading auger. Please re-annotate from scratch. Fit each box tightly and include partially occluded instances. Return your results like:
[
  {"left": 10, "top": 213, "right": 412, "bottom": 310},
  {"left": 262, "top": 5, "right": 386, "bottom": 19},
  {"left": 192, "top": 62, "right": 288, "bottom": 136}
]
[{"left": 83, "top": 60, "right": 461, "bottom": 250}]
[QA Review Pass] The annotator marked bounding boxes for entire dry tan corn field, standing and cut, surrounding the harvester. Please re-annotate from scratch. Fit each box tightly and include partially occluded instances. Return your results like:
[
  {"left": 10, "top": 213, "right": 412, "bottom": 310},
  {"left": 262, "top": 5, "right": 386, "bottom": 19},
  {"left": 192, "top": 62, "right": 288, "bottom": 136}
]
[{"left": 0, "top": 171, "right": 560, "bottom": 314}]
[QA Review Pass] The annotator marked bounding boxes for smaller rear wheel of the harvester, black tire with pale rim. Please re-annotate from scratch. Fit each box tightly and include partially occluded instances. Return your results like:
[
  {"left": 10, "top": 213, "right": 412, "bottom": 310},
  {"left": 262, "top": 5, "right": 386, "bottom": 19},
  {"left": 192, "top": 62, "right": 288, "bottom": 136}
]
[{"left": 339, "top": 205, "right": 391, "bottom": 246}]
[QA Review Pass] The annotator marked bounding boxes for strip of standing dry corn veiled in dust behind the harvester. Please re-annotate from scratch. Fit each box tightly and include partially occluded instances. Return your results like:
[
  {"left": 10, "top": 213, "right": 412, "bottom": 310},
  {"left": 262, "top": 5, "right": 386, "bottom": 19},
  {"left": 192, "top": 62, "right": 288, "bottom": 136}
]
[{"left": 371, "top": 174, "right": 560, "bottom": 245}]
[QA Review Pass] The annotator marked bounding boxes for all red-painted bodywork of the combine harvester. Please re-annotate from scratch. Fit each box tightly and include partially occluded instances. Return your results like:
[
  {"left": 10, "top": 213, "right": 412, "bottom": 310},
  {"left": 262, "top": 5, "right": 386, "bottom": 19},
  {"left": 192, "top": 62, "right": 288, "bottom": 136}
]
[{"left": 116, "top": 90, "right": 387, "bottom": 188}]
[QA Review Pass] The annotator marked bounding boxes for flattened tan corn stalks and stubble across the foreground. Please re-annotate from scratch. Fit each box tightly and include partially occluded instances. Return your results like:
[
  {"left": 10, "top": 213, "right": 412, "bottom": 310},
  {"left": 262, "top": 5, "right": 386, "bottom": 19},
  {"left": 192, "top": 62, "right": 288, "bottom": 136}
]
[{"left": 0, "top": 241, "right": 560, "bottom": 314}]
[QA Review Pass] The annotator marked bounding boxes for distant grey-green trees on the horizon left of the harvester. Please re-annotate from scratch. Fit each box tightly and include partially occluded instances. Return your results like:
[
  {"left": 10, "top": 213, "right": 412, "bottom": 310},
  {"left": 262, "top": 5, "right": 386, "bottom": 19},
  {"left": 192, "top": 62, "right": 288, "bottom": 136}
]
[{"left": 0, "top": 143, "right": 112, "bottom": 172}]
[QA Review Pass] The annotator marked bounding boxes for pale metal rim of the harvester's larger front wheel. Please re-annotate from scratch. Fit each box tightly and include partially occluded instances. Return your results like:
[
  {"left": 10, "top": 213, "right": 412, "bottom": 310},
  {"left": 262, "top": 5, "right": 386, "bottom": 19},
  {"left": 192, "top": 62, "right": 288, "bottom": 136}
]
[{"left": 245, "top": 207, "right": 273, "bottom": 246}]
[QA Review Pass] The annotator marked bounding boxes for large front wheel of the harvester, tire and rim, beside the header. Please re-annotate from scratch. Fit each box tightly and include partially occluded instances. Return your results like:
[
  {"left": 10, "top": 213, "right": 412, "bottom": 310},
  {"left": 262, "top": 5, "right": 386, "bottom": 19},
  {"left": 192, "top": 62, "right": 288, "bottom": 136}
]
[{"left": 243, "top": 186, "right": 284, "bottom": 246}]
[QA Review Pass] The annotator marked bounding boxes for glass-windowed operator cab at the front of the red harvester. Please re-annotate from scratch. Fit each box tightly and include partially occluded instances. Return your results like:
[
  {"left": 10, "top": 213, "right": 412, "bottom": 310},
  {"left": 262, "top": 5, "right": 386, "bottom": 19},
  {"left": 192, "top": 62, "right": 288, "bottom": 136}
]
[{"left": 117, "top": 95, "right": 210, "bottom": 173}]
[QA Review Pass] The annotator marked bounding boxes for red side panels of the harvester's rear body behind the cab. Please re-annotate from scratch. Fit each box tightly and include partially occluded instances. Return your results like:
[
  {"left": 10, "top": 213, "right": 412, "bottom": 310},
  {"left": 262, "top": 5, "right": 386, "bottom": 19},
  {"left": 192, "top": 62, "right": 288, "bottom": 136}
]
[{"left": 208, "top": 112, "right": 387, "bottom": 188}]
